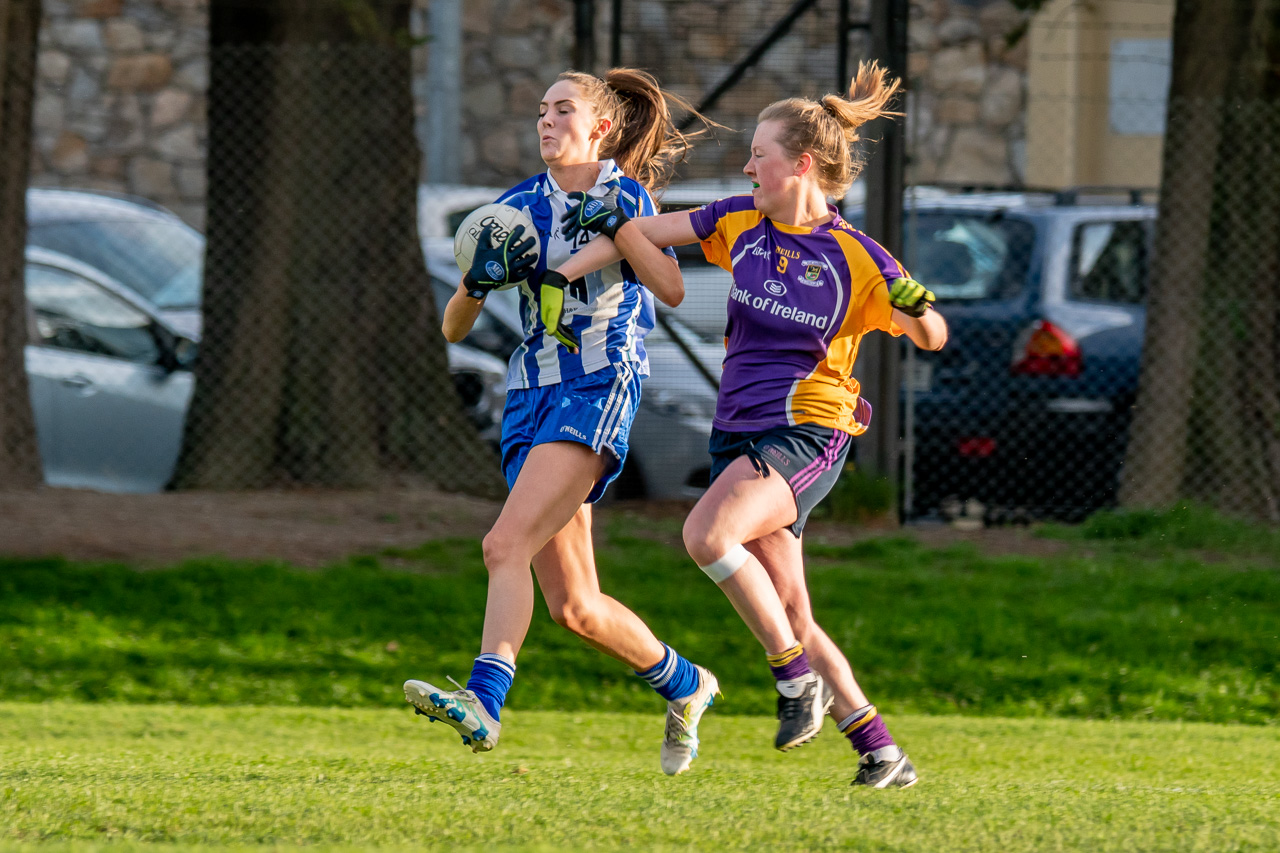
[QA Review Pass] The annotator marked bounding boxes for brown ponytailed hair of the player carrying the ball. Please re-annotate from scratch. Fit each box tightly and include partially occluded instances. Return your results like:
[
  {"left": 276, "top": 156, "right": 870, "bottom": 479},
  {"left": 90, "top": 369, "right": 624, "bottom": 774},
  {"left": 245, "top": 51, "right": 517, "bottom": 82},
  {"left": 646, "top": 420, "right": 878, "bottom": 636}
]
[{"left": 557, "top": 68, "right": 719, "bottom": 193}]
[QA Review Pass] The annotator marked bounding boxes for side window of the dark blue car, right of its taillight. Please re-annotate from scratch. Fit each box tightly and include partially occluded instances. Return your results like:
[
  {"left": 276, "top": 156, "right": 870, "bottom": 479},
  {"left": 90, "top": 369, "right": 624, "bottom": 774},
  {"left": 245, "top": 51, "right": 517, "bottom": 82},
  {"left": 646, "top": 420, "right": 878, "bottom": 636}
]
[{"left": 1069, "top": 220, "right": 1151, "bottom": 305}]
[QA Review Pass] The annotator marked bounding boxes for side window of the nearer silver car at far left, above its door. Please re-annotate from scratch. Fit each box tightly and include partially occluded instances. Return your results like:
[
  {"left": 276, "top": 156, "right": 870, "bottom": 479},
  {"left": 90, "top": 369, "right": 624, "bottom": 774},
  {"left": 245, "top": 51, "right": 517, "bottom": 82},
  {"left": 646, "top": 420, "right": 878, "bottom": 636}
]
[{"left": 26, "top": 264, "right": 160, "bottom": 364}]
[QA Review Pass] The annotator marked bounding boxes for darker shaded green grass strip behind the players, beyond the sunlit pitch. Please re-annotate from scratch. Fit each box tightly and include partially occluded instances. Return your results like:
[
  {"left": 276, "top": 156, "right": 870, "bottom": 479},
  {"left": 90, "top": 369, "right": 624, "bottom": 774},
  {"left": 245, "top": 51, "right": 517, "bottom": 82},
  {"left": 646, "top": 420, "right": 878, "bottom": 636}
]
[{"left": 0, "top": 504, "right": 1280, "bottom": 724}]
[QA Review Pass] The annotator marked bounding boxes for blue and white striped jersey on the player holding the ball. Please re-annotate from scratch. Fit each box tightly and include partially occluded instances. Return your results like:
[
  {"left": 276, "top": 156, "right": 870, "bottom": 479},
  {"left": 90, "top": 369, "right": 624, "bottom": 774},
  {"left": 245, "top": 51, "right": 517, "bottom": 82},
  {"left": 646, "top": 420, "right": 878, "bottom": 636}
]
[{"left": 498, "top": 160, "right": 675, "bottom": 391}]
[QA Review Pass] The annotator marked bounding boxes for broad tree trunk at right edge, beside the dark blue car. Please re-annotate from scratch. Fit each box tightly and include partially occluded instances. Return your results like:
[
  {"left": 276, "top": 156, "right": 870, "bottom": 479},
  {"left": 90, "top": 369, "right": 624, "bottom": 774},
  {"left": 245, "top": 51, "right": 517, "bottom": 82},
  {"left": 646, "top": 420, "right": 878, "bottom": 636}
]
[{"left": 1121, "top": 0, "right": 1280, "bottom": 520}]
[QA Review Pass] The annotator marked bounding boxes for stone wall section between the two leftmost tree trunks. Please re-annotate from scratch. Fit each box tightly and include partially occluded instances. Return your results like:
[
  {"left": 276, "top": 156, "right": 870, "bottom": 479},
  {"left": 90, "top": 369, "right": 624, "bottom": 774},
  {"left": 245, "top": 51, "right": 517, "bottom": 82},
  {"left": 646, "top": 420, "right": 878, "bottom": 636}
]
[{"left": 32, "top": 0, "right": 209, "bottom": 227}]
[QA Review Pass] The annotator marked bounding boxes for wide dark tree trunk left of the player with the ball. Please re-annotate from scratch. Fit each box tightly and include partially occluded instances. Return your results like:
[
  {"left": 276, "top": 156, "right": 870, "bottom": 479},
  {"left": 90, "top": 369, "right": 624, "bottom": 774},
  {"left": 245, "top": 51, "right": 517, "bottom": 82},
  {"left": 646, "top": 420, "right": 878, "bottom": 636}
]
[{"left": 177, "top": 0, "right": 502, "bottom": 494}]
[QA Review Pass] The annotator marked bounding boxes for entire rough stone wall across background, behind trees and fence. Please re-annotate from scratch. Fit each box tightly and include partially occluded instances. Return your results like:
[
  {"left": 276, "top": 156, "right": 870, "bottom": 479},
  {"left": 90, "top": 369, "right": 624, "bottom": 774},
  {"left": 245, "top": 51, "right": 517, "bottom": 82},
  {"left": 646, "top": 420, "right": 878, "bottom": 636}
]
[{"left": 32, "top": 0, "right": 1027, "bottom": 228}]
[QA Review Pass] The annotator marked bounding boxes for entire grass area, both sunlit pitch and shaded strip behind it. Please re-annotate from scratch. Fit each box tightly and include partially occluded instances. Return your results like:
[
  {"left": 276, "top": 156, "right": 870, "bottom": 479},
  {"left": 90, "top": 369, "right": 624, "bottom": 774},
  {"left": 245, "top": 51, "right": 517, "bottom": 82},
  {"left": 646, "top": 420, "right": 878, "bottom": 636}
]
[{"left": 0, "top": 511, "right": 1280, "bottom": 852}]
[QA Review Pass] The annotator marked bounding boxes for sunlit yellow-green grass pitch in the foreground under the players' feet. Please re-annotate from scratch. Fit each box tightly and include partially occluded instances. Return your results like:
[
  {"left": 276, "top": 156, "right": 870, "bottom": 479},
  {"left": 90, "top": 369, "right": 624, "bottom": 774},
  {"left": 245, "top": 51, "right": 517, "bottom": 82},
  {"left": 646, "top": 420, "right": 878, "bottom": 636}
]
[{"left": 0, "top": 703, "right": 1280, "bottom": 852}]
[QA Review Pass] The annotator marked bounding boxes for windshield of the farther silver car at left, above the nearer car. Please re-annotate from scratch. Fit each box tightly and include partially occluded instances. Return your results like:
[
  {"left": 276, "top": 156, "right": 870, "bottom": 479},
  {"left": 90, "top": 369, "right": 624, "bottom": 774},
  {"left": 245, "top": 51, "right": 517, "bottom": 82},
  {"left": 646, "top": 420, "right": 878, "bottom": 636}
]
[{"left": 27, "top": 219, "right": 205, "bottom": 309}]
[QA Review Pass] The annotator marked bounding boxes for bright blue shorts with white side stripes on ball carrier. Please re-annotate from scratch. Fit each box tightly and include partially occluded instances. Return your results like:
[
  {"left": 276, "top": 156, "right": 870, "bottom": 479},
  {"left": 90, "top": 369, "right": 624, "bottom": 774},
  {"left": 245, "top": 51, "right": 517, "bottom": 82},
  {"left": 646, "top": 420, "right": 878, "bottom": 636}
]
[{"left": 502, "top": 364, "right": 640, "bottom": 503}]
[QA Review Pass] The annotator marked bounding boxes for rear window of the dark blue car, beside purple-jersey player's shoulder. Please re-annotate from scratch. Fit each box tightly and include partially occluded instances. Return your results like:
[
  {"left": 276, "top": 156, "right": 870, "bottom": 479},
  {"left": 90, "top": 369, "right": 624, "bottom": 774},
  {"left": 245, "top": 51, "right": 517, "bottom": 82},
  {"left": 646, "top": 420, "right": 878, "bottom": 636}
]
[{"left": 902, "top": 211, "right": 1036, "bottom": 300}]
